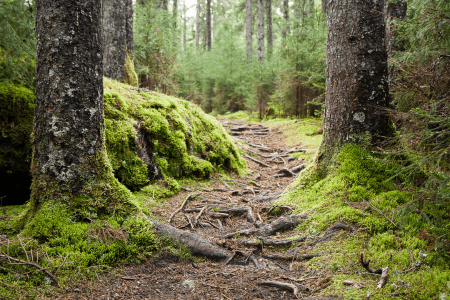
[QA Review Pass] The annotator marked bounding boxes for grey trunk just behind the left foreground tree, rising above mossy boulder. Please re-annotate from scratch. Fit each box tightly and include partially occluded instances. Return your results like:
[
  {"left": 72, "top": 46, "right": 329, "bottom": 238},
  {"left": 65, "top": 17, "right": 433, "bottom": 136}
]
[{"left": 102, "top": 0, "right": 128, "bottom": 81}]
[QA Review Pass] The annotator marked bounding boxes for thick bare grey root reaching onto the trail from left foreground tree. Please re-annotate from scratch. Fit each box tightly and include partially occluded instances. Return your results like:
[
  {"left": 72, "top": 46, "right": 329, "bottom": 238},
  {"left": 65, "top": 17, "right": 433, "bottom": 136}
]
[{"left": 148, "top": 217, "right": 232, "bottom": 259}]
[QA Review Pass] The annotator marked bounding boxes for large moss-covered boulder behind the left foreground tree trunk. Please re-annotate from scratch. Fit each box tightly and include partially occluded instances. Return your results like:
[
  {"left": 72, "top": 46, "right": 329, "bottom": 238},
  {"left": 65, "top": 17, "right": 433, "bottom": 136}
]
[{"left": 0, "top": 78, "right": 246, "bottom": 203}]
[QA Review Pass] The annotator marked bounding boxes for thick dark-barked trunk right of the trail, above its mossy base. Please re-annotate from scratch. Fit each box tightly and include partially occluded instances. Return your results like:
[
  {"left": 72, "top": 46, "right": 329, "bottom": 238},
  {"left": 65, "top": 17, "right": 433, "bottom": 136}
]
[{"left": 321, "top": 0, "right": 389, "bottom": 157}]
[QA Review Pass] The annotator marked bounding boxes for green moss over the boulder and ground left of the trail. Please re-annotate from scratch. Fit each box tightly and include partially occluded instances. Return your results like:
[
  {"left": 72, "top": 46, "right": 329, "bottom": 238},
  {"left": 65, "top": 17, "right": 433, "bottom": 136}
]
[{"left": 0, "top": 79, "right": 246, "bottom": 297}]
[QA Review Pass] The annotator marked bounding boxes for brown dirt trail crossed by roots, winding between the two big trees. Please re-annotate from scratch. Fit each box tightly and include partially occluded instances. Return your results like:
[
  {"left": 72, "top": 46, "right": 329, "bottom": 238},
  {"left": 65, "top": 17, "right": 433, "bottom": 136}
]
[{"left": 58, "top": 120, "right": 333, "bottom": 300}]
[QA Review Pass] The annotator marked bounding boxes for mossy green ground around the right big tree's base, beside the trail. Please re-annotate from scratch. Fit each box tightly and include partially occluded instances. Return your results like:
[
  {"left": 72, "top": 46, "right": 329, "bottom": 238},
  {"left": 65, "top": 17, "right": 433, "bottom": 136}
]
[{"left": 278, "top": 145, "right": 450, "bottom": 299}]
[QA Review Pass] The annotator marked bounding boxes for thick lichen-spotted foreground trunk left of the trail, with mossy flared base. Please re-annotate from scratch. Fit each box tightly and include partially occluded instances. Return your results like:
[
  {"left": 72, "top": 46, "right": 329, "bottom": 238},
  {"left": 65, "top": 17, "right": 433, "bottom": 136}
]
[{"left": 29, "top": 0, "right": 132, "bottom": 225}]
